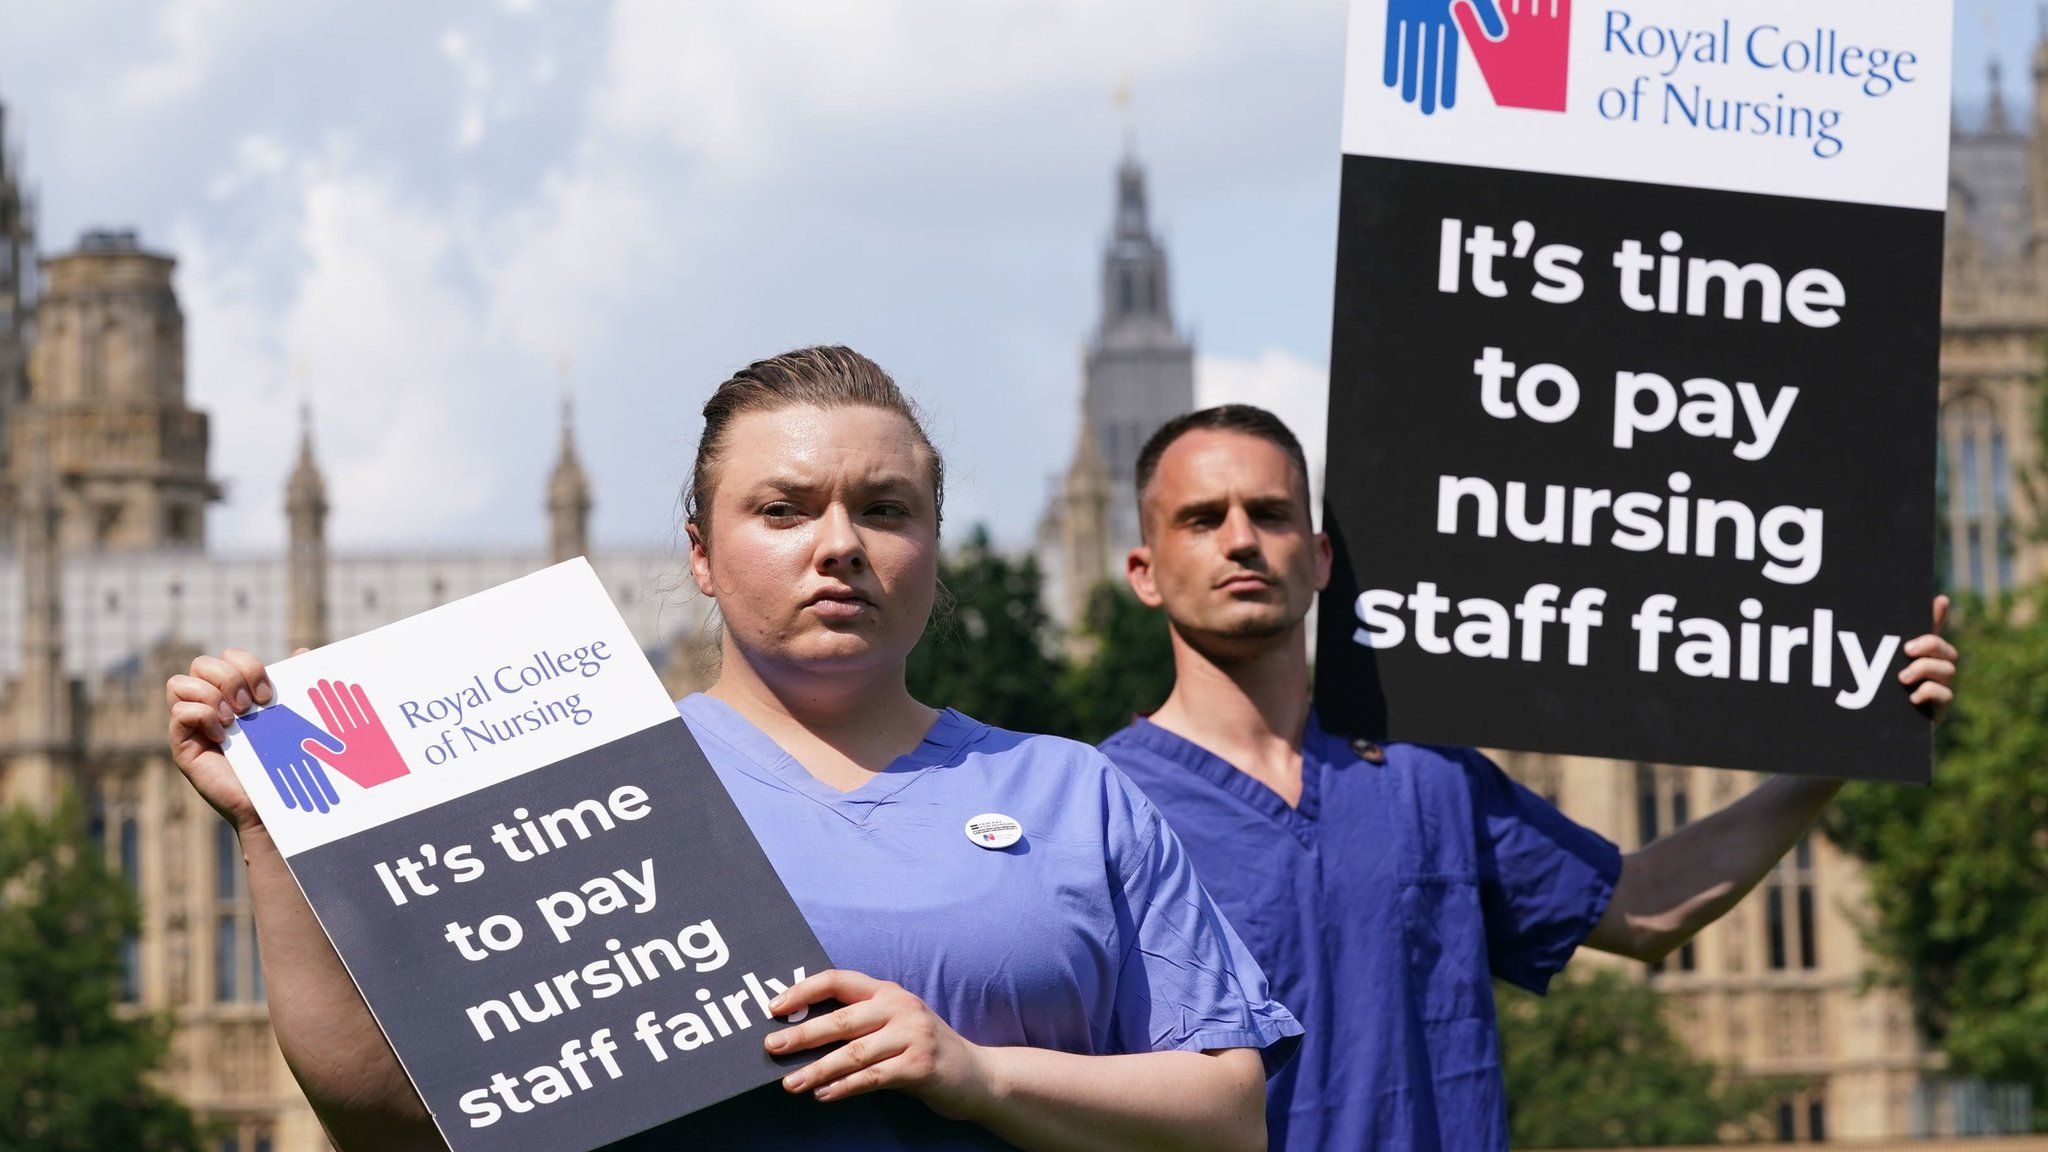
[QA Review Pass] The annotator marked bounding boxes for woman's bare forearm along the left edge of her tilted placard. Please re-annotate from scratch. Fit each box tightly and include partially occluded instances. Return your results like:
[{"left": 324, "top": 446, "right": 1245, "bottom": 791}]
[{"left": 242, "top": 826, "right": 444, "bottom": 1152}]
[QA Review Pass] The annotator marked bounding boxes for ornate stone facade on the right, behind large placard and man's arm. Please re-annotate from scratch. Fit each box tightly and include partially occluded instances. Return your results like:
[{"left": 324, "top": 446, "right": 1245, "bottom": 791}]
[{"left": 1499, "top": 53, "right": 2048, "bottom": 1146}]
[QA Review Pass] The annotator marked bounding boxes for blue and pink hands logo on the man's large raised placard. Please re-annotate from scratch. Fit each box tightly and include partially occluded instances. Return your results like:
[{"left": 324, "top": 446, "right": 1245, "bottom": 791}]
[{"left": 1384, "top": 0, "right": 1571, "bottom": 115}]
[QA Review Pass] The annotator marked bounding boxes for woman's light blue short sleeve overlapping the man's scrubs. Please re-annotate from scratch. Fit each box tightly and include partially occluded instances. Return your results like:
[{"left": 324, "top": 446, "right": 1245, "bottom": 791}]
[{"left": 1104, "top": 763, "right": 1303, "bottom": 1076}]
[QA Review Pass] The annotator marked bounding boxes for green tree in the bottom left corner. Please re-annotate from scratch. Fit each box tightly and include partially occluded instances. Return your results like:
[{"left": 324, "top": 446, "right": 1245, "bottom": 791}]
[{"left": 0, "top": 806, "right": 201, "bottom": 1152}]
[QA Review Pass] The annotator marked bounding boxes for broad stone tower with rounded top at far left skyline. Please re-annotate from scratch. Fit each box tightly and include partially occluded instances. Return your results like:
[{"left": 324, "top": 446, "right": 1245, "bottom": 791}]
[{"left": 10, "top": 232, "right": 221, "bottom": 551}]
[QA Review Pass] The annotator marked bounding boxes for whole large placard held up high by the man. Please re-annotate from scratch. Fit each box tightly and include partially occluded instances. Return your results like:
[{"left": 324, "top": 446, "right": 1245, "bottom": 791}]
[{"left": 1317, "top": 0, "right": 1952, "bottom": 781}]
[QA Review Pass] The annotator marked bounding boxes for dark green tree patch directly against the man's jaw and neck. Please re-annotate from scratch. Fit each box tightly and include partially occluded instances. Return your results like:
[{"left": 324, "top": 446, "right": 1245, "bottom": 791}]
[{"left": 1061, "top": 580, "right": 1174, "bottom": 744}]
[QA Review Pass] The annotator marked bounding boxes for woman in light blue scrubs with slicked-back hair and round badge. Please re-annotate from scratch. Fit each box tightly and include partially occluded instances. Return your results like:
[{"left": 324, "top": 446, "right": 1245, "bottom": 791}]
[{"left": 166, "top": 348, "right": 1300, "bottom": 1150}]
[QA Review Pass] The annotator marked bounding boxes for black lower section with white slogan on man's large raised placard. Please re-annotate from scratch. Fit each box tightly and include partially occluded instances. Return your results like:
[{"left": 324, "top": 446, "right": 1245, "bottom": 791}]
[{"left": 1317, "top": 156, "right": 1942, "bottom": 781}]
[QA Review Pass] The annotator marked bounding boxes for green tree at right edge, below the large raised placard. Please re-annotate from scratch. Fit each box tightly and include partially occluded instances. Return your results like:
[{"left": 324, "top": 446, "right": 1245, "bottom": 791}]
[{"left": 1829, "top": 586, "right": 2048, "bottom": 1123}]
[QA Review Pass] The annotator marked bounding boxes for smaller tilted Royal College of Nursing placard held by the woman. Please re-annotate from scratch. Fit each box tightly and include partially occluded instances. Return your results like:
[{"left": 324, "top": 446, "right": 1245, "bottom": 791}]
[{"left": 225, "top": 560, "right": 829, "bottom": 1152}]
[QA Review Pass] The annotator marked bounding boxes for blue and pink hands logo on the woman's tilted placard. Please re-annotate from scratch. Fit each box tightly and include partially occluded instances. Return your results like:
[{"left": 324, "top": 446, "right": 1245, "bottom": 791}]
[{"left": 240, "top": 681, "right": 410, "bottom": 812}]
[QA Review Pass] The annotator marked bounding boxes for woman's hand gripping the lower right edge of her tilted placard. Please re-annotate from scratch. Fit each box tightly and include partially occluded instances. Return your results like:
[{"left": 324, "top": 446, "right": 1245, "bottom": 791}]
[{"left": 764, "top": 970, "right": 991, "bottom": 1119}]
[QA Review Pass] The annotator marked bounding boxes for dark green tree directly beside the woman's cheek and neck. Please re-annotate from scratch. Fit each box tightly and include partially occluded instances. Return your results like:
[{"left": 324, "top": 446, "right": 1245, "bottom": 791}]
[{"left": 907, "top": 527, "right": 1071, "bottom": 734}]
